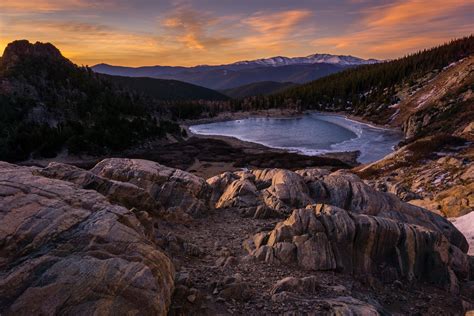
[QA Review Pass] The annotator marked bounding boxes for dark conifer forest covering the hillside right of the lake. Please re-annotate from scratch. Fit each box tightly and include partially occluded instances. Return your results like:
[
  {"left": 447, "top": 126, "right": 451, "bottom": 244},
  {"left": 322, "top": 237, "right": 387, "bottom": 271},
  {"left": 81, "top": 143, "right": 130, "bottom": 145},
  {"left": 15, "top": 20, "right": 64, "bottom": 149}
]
[{"left": 268, "top": 35, "right": 474, "bottom": 123}]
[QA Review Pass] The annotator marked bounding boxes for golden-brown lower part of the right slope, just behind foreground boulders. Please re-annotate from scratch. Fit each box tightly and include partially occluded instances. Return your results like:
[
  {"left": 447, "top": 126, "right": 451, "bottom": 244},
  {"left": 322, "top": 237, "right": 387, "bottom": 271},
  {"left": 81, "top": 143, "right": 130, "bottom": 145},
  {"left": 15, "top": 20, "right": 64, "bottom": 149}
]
[{"left": 354, "top": 137, "right": 474, "bottom": 217}]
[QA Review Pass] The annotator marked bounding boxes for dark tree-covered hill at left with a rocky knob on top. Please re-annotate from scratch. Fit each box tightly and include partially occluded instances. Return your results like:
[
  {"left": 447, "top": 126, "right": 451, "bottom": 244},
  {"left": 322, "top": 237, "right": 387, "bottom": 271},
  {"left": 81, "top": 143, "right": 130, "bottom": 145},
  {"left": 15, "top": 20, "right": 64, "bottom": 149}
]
[{"left": 0, "top": 40, "right": 179, "bottom": 161}]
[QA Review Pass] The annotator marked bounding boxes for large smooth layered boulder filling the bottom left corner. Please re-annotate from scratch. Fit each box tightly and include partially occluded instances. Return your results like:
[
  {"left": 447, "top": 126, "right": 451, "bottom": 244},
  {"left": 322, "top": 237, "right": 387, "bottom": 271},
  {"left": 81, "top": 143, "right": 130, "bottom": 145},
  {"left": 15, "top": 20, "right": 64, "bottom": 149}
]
[{"left": 0, "top": 162, "right": 174, "bottom": 315}]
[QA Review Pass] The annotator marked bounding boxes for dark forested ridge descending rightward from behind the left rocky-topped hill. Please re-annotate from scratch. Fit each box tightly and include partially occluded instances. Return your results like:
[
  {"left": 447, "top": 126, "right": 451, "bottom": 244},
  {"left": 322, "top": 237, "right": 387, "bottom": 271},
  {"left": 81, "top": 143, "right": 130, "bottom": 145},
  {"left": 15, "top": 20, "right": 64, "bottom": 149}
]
[{"left": 103, "top": 75, "right": 228, "bottom": 101}]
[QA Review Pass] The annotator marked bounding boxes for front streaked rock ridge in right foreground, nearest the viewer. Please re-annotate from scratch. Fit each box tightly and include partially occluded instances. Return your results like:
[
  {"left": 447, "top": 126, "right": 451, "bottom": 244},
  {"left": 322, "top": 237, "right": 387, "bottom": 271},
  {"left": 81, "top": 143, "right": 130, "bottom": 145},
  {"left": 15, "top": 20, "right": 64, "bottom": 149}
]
[{"left": 251, "top": 204, "right": 469, "bottom": 292}]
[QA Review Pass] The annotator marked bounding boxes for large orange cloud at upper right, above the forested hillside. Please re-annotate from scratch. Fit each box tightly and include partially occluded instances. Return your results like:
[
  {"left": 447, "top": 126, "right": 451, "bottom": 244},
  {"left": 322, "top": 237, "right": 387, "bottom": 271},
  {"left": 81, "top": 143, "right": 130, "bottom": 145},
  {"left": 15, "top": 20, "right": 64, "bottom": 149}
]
[{"left": 312, "top": 0, "right": 474, "bottom": 59}]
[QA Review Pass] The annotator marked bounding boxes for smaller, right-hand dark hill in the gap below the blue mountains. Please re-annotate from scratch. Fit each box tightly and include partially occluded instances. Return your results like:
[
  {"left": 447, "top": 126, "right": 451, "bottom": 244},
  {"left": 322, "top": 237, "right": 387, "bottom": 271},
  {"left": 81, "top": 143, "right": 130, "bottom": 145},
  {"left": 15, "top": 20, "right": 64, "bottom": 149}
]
[{"left": 220, "top": 81, "right": 296, "bottom": 99}]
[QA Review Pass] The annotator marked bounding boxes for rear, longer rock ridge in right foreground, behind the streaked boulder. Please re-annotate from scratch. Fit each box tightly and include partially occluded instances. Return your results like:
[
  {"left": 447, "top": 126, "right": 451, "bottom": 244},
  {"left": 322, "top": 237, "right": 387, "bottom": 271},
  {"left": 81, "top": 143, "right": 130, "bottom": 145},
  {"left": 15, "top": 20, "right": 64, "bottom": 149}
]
[{"left": 208, "top": 169, "right": 468, "bottom": 252}]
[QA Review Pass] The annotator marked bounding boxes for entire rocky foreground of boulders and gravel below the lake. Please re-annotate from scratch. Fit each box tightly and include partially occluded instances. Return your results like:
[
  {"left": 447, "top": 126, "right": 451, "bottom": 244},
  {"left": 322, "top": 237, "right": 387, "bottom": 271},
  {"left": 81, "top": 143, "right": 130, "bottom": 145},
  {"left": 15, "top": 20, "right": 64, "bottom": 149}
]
[{"left": 0, "top": 159, "right": 474, "bottom": 315}]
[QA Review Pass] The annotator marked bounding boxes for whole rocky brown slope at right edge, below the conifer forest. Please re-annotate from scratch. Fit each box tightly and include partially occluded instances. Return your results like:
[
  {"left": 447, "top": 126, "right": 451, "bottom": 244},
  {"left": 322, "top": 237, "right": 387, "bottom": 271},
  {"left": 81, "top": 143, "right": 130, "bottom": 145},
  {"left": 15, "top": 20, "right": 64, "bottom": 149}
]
[{"left": 350, "top": 51, "right": 474, "bottom": 223}]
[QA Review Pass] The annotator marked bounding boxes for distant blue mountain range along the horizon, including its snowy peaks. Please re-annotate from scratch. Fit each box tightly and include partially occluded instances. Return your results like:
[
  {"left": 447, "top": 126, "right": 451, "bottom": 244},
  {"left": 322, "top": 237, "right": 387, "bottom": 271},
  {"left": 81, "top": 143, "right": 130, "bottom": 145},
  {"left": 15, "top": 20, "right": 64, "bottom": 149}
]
[{"left": 92, "top": 54, "right": 379, "bottom": 90}]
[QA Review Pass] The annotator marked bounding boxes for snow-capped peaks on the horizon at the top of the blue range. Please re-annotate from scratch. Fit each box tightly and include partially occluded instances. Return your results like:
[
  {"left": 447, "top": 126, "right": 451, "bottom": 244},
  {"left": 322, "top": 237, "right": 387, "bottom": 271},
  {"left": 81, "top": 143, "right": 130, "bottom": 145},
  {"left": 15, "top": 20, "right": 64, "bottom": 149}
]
[{"left": 231, "top": 54, "right": 380, "bottom": 67}]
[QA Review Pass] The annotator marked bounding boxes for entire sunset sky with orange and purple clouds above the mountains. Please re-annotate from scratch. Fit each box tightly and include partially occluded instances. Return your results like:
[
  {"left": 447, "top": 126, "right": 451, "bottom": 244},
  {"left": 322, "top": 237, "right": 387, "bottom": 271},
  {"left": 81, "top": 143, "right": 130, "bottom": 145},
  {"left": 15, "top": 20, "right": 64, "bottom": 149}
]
[{"left": 0, "top": 0, "right": 474, "bottom": 66}]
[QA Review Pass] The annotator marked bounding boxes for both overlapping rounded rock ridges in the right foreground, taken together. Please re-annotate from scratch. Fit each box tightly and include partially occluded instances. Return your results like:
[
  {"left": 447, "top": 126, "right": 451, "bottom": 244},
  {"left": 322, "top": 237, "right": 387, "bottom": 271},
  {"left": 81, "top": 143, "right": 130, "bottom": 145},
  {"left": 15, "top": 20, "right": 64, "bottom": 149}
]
[{"left": 208, "top": 169, "right": 469, "bottom": 292}]
